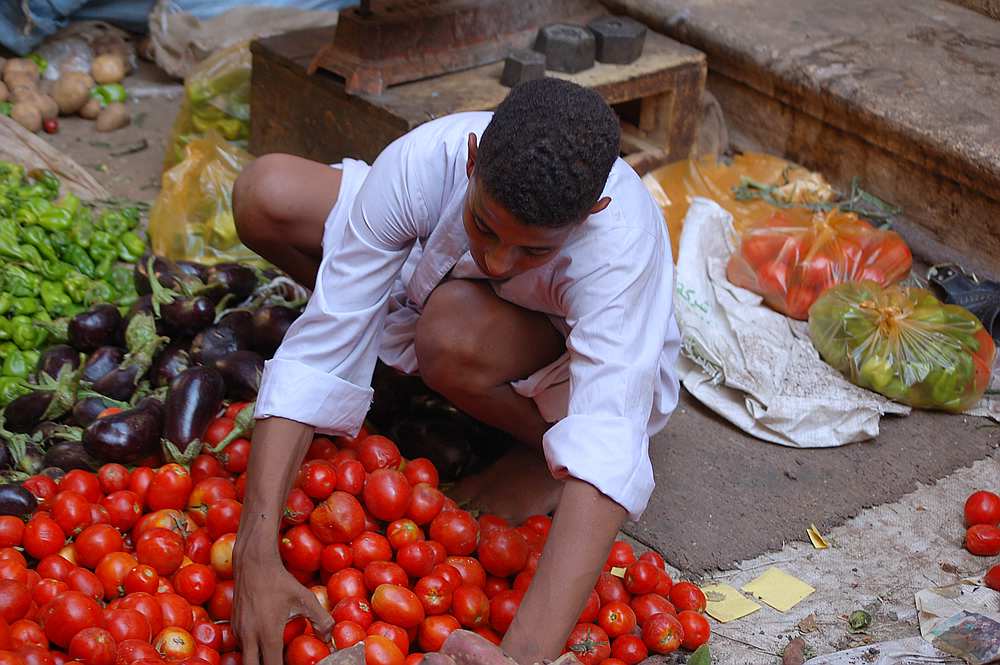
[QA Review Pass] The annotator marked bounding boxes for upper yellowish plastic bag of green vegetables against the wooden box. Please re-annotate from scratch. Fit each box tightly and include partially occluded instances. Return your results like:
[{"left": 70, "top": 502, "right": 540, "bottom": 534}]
[{"left": 163, "top": 42, "right": 251, "bottom": 171}]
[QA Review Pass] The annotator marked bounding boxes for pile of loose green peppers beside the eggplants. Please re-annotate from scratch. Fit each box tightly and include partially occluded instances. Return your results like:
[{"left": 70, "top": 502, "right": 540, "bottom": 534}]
[{"left": 0, "top": 161, "right": 146, "bottom": 404}]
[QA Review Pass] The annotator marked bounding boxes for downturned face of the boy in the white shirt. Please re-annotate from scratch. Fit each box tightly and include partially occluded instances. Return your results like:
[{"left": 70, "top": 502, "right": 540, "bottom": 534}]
[{"left": 462, "top": 176, "right": 576, "bottom": 279}]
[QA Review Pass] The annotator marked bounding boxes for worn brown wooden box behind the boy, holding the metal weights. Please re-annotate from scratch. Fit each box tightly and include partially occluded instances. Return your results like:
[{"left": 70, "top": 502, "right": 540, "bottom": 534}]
[{"left": 250, "top": 28, "right": 706, "bottom": 171}]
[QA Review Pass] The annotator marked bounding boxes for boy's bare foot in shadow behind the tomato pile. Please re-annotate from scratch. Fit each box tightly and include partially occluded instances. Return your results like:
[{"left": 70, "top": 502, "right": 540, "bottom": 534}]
[{"left": 449, "top": 446, "right": 563, "bottom": 524}]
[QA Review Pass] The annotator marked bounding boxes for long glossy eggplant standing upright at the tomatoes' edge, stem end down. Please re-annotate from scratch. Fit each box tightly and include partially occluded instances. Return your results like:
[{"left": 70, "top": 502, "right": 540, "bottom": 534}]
[{"left": 163, "top": 367, "right": 226, "bottom": 457}]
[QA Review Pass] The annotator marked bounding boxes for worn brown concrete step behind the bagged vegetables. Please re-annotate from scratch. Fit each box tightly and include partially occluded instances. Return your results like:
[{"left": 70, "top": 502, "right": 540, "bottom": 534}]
[{"left": 605, "top": 0, "right": 1000, "bottom": 277}]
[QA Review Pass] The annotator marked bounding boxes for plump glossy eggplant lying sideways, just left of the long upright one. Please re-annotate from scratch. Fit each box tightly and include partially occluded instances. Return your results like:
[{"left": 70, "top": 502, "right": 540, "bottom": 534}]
[{"left": 83, "top": 408, "right": 162, "bottom": 464}]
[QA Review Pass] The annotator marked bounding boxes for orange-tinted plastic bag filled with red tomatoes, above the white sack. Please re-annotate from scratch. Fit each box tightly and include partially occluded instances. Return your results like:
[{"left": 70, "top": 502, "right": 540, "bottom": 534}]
[{"left": 726, "top": 209, "right": 913, "bottom": 320}]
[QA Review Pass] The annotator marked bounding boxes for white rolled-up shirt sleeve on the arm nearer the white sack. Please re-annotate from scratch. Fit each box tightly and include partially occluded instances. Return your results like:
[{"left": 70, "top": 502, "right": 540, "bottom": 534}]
[{"left": 543, "top": 227, "right": 673, "bottom": 519}]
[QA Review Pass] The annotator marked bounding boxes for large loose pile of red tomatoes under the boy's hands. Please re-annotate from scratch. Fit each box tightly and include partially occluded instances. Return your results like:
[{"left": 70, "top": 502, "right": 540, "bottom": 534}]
[{"left": 0, "top": 404, "right": 710, "bottom": 665}]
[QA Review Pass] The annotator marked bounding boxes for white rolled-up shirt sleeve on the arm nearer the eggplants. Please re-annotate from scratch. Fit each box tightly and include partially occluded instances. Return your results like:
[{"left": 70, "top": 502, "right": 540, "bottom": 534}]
[{"left": 256, "top": 137, "right": 429, "bottom": 436}]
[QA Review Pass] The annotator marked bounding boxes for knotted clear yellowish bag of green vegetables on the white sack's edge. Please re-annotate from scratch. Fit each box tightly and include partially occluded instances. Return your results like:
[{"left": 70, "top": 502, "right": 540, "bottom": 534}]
[{"left": 809, "top": 281, "right": 996, "bottom": 412}]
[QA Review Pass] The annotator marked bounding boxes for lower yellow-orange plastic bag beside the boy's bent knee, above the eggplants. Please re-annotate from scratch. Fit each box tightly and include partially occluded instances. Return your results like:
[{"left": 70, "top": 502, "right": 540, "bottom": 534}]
[{"left": 149, "top": 133, "right": 264, "bottom": 265}]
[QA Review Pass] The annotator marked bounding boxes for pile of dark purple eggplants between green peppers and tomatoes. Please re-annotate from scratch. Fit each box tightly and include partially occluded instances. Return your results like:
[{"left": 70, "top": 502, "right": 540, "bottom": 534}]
[{"left": 0, "top": 256, "right": 305, "bottom": 480}]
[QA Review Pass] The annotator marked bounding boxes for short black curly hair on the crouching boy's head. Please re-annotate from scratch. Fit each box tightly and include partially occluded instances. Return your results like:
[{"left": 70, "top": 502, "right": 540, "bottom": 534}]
[{"left": 475, "top": 78, "right": 621, "bottom": 227}]
